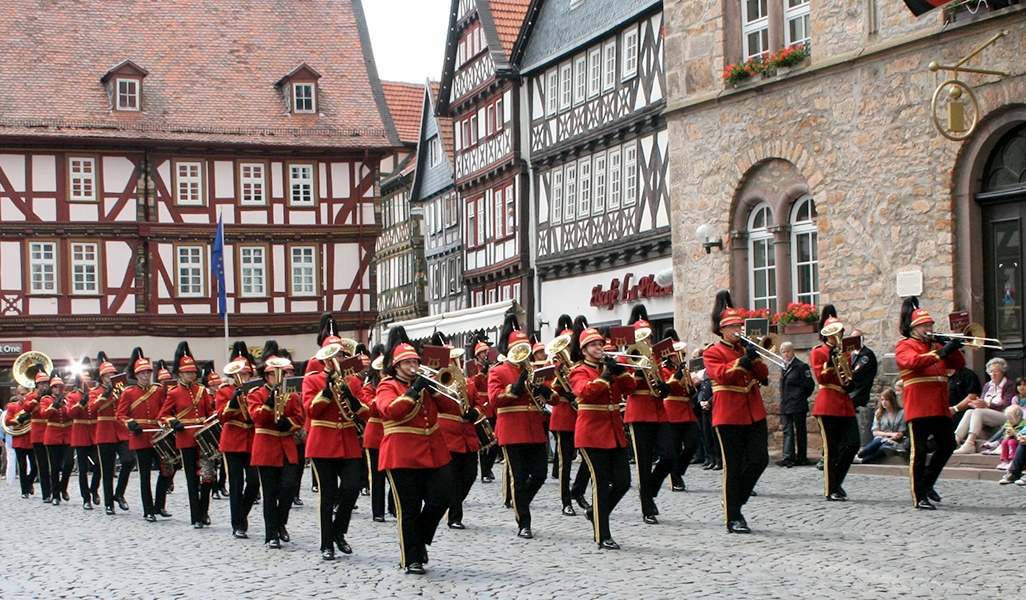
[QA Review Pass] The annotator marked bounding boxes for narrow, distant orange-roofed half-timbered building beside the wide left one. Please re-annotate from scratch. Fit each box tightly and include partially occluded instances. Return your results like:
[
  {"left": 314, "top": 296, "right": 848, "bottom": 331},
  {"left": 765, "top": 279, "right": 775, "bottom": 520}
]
[{"left": 373, "top": 81, "right": 428, "bottom": 341}]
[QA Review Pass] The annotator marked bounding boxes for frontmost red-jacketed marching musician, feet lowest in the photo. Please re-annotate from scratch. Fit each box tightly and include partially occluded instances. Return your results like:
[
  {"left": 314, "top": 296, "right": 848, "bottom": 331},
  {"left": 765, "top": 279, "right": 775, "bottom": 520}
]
[{"left": 376, "top": 325, "right": 455, "bottom": 574}]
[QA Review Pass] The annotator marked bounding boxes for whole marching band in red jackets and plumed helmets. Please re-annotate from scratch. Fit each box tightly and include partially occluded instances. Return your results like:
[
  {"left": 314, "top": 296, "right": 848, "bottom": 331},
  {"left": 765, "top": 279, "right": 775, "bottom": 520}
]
[{"left": 3, "top": 291, "right": 990, "bottom": 574}]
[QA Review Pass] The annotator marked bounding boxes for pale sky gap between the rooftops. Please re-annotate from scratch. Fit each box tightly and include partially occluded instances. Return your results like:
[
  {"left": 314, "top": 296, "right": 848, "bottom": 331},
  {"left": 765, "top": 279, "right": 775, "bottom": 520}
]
[{"left": 363, "top": 0, "right": 451, "bottom": 83}]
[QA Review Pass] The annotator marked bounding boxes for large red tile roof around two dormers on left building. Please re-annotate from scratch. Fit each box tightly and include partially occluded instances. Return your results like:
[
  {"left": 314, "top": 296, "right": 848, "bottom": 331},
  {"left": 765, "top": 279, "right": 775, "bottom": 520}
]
[{"left": 0, "top": 0, "right": 396, "bottom": 149}]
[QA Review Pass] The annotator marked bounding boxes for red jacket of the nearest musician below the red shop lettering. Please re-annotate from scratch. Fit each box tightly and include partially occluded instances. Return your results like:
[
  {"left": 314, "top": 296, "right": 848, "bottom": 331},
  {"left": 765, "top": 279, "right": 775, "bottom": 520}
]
[{"left": 570, "top": 360, "right": 637, "bottom": 448}]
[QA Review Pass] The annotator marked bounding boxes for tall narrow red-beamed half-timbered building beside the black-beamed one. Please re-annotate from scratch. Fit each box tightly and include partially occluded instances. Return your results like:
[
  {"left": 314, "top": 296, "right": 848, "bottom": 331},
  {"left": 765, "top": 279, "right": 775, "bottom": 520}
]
[{"left": 437, "top": 0, "right": 534, "bottom": 326}]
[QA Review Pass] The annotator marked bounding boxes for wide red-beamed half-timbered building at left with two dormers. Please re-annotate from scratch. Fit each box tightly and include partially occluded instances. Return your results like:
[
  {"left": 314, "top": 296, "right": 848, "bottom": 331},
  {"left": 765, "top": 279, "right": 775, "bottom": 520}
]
[{"left": 0, "top": 0, "right": 398, "bottom": 383}]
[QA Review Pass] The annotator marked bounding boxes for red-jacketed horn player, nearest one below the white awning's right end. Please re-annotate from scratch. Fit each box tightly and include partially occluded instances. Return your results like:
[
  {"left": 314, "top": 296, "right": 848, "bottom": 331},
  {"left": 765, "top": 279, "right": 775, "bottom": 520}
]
[{"left": 488, "top": 315, "right": 552, "bottom": 539}]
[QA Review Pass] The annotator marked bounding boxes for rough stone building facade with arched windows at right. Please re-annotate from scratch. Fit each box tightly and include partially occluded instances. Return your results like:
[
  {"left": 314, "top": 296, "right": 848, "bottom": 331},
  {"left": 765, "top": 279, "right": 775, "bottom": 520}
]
[{"left": 664, "top": 0, "right": 1026, "bottom": 438}]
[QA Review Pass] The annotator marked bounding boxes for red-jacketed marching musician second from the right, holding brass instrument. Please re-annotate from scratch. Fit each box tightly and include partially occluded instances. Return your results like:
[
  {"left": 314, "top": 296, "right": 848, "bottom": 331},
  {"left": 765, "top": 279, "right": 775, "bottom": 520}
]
[{"left": 810, "top": 305, "right": 859, "bottom": 502}]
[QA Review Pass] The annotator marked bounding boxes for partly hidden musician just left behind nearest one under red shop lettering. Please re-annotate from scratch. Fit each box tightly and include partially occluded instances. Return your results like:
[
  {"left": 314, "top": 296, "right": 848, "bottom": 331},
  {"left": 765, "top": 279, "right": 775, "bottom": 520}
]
[{"left": 549, "top": 315, "right": 591, "bottom": 517}]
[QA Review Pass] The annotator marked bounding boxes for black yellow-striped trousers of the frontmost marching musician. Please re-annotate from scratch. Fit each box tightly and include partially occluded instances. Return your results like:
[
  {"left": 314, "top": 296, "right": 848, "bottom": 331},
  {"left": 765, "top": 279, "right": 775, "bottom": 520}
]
[{"left": 386, "top": 465, "right": 452, "bottom": 567}]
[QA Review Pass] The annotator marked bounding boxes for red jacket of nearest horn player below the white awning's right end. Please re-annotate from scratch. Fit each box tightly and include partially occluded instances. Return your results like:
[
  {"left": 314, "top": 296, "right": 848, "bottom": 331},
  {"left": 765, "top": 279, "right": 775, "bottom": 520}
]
[{"left": 488, "top": 362, "right": 549, "bottom": 446}]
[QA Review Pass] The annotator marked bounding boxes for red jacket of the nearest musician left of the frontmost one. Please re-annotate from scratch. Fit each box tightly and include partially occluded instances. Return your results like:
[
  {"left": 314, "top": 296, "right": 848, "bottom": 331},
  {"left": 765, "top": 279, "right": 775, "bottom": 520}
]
[{"left": 303, "top": 372, "right": 370, "bottom": 458}]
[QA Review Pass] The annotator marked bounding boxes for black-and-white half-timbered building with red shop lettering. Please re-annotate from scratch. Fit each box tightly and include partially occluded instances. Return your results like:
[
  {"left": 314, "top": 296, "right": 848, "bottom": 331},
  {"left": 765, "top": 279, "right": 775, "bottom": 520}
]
[{"left": 513, "top": 0, "right": 673, "bottom": 337}]
